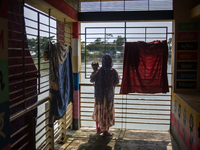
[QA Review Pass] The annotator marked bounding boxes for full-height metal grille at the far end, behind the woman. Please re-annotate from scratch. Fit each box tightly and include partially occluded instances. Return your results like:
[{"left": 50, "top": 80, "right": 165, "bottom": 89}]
[{"left": 80, "top": 22, "right": 172, "bottom": 130}]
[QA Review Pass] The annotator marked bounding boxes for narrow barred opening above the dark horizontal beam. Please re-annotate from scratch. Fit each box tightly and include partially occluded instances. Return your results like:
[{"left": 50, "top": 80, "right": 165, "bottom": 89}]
[{"left": 79, "top": 0, "right": 173, "bottom": 12}]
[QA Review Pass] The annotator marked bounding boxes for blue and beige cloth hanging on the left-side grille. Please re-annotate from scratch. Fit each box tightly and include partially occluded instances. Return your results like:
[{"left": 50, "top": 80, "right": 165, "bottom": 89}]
[{"left": 43, "top": 42, "right": 74, "bottom": 127}]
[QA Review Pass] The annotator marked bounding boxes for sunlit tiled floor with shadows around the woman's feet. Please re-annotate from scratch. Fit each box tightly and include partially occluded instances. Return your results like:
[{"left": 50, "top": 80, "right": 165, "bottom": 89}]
[{"left": 55, "top": 127, "right": 179, "bottom": 150}]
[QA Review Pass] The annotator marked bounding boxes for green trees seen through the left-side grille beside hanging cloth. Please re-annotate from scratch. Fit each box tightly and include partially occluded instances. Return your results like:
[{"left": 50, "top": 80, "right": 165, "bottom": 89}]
[{"left": 27, "top": 36, "right": 55, "bottom": 56}]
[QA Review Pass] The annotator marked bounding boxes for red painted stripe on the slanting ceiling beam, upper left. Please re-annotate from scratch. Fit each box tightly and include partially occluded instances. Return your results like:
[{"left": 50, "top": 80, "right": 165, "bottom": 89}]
[{"left": 44, "top": 0, "right": 78, "bottom": 21}]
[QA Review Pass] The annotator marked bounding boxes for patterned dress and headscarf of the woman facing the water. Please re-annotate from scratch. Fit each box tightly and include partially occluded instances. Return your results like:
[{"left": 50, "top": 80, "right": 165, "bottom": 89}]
[{"left": 91, "top": 55, "right": 119, "bottom": 131}]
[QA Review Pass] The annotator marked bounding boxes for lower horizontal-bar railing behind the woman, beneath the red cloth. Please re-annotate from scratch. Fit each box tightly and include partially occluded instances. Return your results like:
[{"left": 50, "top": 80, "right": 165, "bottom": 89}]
[{"left": 80, "top": 83, "right": 171, "bottom": 130}]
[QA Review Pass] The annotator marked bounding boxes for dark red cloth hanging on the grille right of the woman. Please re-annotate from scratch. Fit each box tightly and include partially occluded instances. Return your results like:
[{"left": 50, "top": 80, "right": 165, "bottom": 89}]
[{"left": 120, "top": 40, "right": 169, "bottom": 94}]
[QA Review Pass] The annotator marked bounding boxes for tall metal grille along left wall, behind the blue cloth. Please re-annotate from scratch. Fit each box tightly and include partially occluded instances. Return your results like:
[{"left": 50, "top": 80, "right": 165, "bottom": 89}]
[{"left": 8, "top": 0, "right": 72, "bottom": 149}]
